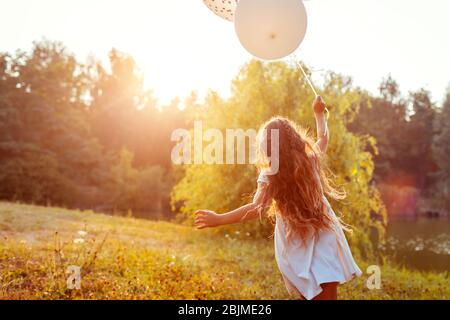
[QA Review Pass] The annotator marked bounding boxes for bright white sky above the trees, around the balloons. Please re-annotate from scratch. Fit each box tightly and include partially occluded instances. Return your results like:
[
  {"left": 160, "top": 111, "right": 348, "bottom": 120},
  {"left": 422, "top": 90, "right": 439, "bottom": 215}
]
[{"left": 0, "top": 0, "right": 450, "bottom": 103}]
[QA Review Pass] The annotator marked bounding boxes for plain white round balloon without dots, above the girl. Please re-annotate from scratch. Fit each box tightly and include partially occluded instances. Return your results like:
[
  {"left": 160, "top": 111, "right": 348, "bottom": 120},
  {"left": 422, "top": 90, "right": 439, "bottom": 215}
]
[{"left": 234, "top": 0, "right": 307, "bottom": 60}]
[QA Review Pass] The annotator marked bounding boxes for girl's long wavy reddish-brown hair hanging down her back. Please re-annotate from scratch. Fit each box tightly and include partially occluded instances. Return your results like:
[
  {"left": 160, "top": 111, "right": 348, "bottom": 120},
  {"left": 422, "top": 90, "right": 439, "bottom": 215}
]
[{"left": 258, "top": 117, "right": 345, "bottom": 243}]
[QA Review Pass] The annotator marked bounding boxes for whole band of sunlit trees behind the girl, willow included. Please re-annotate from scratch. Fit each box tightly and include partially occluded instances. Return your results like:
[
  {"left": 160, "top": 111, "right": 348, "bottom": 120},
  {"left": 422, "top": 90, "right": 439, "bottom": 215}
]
[{"left": 0, "top": 40, "right": 450, "bottom": 221}]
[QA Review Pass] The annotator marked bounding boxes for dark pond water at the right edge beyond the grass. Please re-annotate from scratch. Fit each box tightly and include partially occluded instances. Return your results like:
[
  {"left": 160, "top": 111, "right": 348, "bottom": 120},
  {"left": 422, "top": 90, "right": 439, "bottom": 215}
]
[{"left": 385, "top": 218, "right": 450, "bottom": 272}]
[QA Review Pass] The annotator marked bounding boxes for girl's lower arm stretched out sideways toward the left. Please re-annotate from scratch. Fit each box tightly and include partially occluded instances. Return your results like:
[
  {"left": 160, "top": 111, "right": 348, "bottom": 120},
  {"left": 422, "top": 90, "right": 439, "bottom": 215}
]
[{"left": 195, "top": 183, "right": 268, "bottom": 229}]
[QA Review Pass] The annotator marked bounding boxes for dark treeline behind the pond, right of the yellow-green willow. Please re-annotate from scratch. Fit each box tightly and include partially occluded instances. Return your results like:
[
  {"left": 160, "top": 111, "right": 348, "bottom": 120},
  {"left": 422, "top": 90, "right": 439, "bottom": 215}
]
[{"left": 349, "top": 77, "right": 450, "bottom": 216}]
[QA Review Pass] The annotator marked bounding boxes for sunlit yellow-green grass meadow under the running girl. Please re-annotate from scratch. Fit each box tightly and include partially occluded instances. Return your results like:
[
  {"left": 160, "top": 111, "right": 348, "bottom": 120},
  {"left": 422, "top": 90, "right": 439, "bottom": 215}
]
[{"left": 0, "top": 202, "right": 450, "bottom": 299}]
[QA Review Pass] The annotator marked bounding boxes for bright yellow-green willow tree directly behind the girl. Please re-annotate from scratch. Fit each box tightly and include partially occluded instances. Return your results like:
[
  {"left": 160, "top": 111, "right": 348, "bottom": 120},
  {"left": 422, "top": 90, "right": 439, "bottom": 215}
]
[{"left": 172, "top": 61, "right": 385, "bottom": 254}]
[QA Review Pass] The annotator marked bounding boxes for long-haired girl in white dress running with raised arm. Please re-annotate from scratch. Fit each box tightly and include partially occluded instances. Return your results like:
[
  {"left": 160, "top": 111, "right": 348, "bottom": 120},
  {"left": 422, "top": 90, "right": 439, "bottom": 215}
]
[{"left": 195, "top": 97, "right": 361, "bottom": 300}]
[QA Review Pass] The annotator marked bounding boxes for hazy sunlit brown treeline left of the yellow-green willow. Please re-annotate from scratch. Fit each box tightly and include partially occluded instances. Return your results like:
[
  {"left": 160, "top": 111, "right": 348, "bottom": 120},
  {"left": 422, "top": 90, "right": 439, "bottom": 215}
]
[{"left": 0, "top": 41, "right": 195, "bottom": 217}]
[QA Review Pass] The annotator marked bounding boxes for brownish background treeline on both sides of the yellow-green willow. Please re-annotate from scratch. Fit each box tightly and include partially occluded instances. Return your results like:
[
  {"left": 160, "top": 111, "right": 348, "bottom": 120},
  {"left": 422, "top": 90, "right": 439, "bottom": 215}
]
[{"left": 0, "top": 41, "right": 450, "bottom": 218}]
